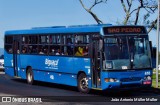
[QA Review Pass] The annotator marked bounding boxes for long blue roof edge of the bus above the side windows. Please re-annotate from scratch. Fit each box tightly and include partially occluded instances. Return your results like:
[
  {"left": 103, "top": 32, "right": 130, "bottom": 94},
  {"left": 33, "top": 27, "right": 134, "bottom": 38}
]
[{"left": 5, "top": 24, "right": 111, "bottom": 35}]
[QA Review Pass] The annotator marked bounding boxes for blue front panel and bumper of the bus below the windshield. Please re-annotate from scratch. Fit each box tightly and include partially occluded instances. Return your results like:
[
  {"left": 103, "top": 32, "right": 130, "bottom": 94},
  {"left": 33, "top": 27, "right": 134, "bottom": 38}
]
[{"left": 101, "top": 70, "right": 152, "bottom": 90}]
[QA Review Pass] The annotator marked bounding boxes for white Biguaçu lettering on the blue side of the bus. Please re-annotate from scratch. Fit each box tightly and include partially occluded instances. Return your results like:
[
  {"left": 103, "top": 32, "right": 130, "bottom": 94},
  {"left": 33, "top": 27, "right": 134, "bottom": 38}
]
[{"left": 45, "top": 58, "right": 59, "bottom": 69}]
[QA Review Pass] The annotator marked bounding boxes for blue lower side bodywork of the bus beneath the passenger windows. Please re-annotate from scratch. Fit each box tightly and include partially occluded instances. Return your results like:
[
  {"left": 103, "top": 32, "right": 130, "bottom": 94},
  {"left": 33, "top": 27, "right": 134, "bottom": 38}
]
[{"left": 5, "top": 50, "right": 91, "bottom": 87}]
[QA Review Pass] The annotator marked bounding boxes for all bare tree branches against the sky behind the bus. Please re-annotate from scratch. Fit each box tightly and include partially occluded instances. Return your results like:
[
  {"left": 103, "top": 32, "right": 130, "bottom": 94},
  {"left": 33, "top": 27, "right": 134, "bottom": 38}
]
[{"left": 79, "top": 0, "right": 158, "bottom": 32}]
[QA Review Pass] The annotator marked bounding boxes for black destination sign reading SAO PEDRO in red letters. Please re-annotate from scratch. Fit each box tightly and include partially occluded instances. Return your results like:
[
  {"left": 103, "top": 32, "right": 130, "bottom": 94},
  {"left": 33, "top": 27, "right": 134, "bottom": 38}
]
[{"left": 103, "top": 26, "right": 146, "bottom": 35}]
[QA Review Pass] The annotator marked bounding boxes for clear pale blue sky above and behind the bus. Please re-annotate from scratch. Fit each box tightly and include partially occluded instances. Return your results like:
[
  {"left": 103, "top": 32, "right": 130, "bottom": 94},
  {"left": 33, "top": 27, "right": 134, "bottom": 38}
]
[{"left": 0, "top": 0, "right": 156, "bottom": 48}]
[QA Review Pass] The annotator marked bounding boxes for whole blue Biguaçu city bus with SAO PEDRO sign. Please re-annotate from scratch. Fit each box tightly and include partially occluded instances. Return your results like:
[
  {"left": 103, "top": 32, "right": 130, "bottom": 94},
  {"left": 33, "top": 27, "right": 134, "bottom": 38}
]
[{"left": 4, "top": 24, "right": 152, "bottom": 93}]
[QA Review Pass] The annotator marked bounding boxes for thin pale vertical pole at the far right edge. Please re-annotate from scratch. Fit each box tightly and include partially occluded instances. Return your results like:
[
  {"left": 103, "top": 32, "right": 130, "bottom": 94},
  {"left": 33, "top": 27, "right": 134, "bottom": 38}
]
[{"left": 156, "top": 0, "right": 160, "bottom": 88}]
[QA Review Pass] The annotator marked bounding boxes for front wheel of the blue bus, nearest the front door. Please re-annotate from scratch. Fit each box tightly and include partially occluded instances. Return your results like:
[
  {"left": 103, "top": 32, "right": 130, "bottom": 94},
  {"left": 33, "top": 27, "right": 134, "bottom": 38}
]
[{"left": 78, "top": 73, "right": 90, "bottom": 93}]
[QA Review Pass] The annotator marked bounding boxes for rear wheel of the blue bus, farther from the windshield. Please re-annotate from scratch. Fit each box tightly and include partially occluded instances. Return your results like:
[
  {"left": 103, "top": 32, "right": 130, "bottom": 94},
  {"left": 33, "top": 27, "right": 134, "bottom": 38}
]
[{"left": 27, "top": 67, "right": 34, "bottom": 85}]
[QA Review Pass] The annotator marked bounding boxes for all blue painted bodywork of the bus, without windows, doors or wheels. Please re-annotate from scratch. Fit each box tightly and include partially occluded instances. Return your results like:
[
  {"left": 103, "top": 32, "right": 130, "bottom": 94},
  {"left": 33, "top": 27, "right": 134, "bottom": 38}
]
[{"left": 4, "top": 24, "right": 152, "bottom": 90}]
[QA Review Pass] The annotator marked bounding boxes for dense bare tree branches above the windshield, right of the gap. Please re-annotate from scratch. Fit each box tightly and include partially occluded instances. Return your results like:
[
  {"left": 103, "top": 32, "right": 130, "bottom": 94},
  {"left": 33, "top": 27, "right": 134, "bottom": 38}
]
[{"left": 121, "top": 0, "right": 158, "bottom": 32}]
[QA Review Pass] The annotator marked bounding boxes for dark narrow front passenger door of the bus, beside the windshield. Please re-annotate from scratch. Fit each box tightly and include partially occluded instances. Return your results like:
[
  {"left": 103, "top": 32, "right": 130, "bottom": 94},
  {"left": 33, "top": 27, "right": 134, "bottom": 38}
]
[{"left": 92, "top": 39, "right": 101, "bottom": 88}]
